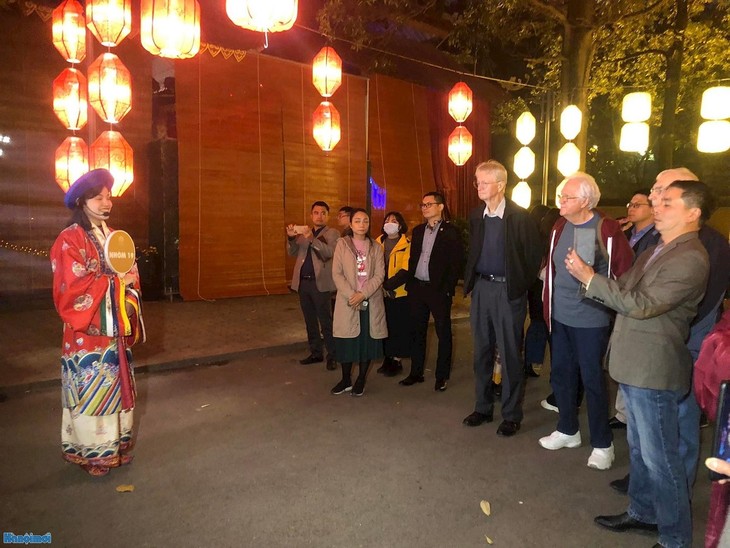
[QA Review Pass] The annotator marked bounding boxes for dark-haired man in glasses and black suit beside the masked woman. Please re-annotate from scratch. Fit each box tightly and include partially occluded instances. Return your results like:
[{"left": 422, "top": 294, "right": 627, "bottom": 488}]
[{"left": 398, "top": 192, "right": 464, "bottom": 392}]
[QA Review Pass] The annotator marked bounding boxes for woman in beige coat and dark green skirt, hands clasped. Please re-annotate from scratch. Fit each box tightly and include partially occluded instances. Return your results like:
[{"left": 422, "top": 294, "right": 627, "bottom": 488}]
[{"left": 331, "top": 208, "right": 388, "bottom": 396}]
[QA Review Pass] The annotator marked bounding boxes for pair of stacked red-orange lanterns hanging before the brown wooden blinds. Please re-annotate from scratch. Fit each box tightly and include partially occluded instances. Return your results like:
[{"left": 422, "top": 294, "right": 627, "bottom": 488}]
[{"left": 312, "top": 46, "right": 342, "bottom": 152}]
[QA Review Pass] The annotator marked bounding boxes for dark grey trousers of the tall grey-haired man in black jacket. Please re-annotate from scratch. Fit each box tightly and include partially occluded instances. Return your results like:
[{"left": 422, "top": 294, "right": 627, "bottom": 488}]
[{"left": 471, "top": 278, "right": 527, "bottom": 422}]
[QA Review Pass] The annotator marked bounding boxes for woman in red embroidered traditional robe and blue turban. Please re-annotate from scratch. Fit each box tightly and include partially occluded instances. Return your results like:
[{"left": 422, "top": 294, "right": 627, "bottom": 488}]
[{"left": 51, "top": 169, "right": 144, "bottom": 476}]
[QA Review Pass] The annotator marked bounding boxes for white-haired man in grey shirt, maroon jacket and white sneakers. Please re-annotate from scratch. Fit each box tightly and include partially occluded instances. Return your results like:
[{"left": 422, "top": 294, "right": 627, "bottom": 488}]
[{"left": 539, "top": 172, "right": 634, "bottom": 470}]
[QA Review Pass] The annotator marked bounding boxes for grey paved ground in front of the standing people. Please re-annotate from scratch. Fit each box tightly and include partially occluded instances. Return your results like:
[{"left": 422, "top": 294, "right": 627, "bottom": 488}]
[{"left": 0, "top": 296, "right": 710, "bottom": 547}]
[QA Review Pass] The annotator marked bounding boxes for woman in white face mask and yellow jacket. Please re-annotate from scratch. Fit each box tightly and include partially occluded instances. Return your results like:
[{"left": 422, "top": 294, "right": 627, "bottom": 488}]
[{"left": 377, "top": 211, "right": 411, "bottom": 377}]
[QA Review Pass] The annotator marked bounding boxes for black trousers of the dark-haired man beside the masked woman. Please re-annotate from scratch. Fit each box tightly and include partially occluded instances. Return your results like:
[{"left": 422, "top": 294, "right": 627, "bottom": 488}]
[{"left": 408, "top": 281, "right": 452, "bottom": 380}]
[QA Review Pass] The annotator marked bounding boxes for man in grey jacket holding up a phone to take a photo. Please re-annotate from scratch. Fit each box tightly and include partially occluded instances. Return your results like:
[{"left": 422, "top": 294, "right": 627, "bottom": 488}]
[{"left": 286, "top": 201, "right": 340, "bottom": 370}]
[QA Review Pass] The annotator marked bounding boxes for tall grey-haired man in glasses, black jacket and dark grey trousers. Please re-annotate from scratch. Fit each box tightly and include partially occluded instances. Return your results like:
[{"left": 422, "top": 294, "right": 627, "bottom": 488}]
[{"left": 463, "top": 160, "right": 543, "bottom": 436}]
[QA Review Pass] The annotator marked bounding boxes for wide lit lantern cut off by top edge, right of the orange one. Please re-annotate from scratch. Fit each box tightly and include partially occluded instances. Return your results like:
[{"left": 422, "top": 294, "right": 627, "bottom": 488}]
[{"left": 226, "top": 0, "right": 298, "bottom": 32}]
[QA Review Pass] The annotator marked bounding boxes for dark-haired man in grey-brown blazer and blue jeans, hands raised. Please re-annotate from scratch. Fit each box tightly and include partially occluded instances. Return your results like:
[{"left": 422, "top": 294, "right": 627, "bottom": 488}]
[{"left": 565, "top": 181, "right": 712, "bottom": 547}]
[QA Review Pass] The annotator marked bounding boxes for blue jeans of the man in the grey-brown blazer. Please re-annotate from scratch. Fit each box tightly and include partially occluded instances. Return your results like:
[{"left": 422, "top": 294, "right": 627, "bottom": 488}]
[{"left": 619, "top": 384, "right": 692, "bottom": 548}]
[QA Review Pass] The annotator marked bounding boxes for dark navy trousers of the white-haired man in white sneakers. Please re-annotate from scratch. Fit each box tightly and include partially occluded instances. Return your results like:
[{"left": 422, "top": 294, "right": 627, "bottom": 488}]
[{"left": 550, "top": 320, "right": 613, "bottom": 448}]
